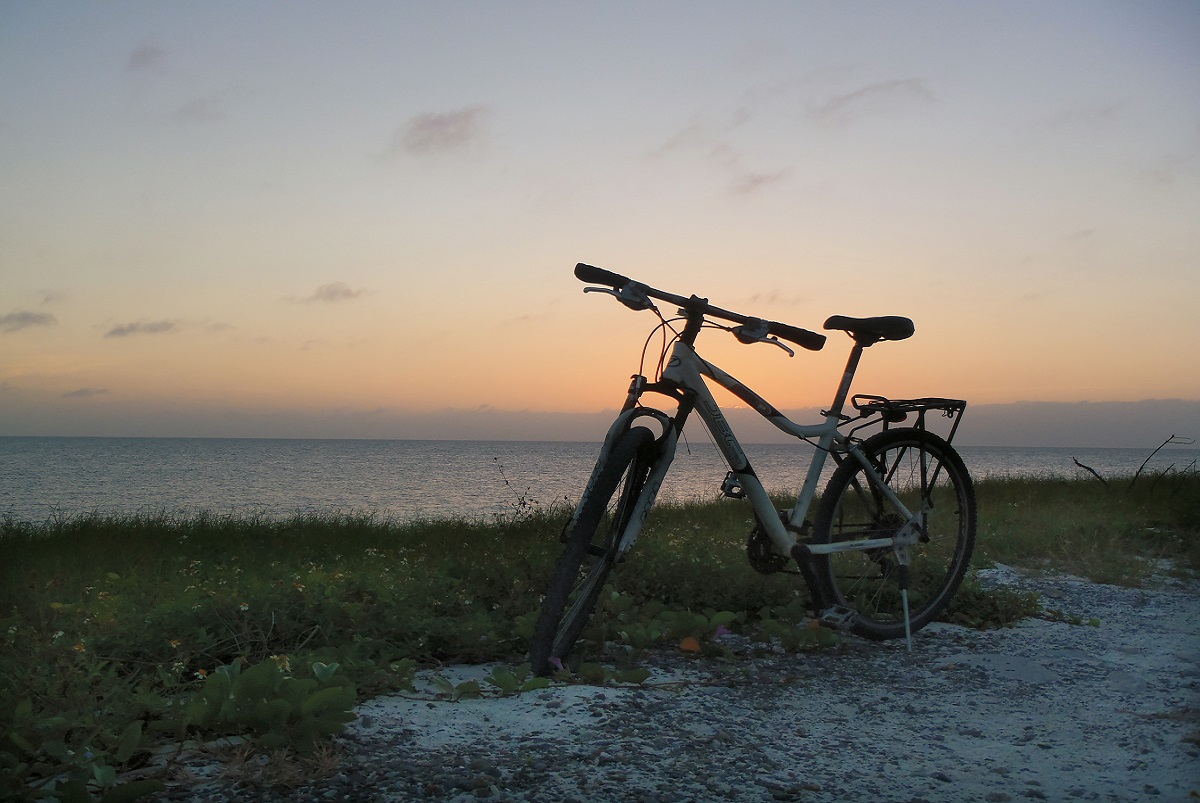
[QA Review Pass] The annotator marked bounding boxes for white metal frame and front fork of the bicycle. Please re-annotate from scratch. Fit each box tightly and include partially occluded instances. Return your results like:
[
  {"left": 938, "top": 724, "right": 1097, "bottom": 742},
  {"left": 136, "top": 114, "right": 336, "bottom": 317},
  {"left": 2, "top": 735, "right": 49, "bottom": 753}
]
[{"left": 597, "top": 340, "right": 924, "bottom": 564}]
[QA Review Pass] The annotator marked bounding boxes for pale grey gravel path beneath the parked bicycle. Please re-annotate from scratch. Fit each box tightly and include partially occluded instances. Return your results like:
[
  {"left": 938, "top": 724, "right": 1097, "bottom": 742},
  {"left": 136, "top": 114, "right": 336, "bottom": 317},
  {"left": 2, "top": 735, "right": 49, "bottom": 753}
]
[{"left": 164, "top": 567, "right": 1200, "bottom": 803}]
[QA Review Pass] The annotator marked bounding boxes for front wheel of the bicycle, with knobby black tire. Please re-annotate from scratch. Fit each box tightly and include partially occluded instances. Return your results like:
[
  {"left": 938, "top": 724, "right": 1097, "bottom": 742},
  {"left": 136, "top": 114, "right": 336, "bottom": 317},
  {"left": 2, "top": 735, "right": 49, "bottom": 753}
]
[{"left": 529, "top": 426, "right": 654, "bottom": 675}]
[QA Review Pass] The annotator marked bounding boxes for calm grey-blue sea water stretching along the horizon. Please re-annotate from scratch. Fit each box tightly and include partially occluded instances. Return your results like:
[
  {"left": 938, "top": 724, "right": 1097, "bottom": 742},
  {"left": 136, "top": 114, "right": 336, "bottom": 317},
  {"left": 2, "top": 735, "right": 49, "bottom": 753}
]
[{"left": 0, "top": 437, "right": 1200, "bottom": 522}]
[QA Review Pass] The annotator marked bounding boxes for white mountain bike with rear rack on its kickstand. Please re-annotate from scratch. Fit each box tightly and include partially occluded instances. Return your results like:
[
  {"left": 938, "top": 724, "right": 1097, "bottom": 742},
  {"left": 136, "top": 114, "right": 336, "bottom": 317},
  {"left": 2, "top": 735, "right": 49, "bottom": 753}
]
[{"left": 529, "top": 263, "right": 976, "bottom": 675}]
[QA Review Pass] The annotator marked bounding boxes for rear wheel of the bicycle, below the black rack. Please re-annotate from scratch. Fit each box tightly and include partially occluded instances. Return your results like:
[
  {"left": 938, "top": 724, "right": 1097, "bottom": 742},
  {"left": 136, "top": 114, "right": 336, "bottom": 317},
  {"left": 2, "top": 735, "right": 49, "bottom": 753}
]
[{"left": 812, "top": 427, "right": 977, "bottom": 641}]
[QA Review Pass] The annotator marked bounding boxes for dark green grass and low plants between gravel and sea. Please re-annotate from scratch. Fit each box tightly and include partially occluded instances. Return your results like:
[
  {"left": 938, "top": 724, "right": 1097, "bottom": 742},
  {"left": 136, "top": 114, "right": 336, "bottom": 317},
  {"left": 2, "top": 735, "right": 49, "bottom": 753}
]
[{"left": 0, "top": 473, "right": 1200, "bottom": 801}]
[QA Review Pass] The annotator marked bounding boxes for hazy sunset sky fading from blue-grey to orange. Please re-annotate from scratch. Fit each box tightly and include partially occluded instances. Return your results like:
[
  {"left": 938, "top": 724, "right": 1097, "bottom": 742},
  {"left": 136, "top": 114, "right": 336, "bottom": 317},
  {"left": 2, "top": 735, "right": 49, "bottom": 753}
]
[{"left": 0, "top": 0, "right": 1200, "bottom": 445}]
